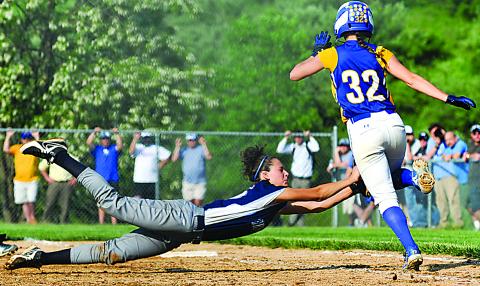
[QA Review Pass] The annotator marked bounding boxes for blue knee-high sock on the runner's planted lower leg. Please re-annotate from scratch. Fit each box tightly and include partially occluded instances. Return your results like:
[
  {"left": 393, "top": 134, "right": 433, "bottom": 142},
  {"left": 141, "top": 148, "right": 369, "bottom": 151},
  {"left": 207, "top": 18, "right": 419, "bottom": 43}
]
[{"left": 382, "top": 207, "right": 419, "bottom": 251}]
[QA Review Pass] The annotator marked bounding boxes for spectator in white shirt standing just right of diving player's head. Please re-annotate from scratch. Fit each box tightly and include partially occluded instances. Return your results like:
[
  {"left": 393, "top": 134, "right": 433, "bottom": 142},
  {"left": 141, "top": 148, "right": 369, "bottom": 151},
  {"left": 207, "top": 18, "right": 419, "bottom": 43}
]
[{"left": 277, "top": 130, "right": 320, "bottom": 226}]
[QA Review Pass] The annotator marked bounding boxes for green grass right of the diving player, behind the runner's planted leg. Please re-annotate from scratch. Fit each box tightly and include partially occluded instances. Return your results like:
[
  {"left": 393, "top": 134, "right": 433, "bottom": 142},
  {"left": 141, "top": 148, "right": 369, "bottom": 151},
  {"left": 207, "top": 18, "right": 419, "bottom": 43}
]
[{"left": 221, "top": 227, "right": 480, "bottom": 258}]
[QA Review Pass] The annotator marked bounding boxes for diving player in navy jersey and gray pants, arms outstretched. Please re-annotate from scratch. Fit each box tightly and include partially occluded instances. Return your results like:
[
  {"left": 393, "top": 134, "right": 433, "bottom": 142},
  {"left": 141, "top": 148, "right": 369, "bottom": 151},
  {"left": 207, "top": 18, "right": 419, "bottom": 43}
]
[{"left": 5, "top": 139, "right": 365, "bottom": 270}]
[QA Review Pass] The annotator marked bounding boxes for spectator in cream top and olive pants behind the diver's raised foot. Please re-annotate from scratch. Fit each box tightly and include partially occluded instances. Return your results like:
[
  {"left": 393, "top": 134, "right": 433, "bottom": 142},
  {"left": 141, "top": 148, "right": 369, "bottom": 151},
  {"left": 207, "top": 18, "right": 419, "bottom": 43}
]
[{"left": 38, "top": 160, "right": 77, "bottom": 224}]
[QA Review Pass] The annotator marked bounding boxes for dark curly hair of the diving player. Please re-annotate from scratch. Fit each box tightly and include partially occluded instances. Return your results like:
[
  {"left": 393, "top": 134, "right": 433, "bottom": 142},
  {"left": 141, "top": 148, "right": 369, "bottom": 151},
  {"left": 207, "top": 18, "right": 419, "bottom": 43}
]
[{"left": 240, "top": 145, "right": 273, "bottom": 182}]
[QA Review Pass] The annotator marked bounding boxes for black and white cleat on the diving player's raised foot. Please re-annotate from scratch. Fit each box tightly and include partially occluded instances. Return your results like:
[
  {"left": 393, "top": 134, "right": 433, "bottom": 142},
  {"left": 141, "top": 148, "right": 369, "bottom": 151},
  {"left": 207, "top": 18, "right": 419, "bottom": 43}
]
[{"left": 20, "top": 138, "right": 67, "bottom": 164}]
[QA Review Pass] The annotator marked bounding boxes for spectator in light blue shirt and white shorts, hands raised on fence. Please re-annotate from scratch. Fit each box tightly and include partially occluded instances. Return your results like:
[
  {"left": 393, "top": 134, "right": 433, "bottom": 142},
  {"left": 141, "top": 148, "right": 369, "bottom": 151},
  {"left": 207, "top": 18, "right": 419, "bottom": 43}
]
[{"left": 172, "top": 133, "right": 212, "bottom": 206}]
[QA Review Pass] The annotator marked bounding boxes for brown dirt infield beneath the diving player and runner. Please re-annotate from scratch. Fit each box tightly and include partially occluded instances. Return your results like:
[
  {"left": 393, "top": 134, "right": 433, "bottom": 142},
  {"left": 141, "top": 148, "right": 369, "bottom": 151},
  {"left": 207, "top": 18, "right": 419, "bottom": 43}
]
[{"left": 0, "top": 242, "right": 480, "bottom": 286}]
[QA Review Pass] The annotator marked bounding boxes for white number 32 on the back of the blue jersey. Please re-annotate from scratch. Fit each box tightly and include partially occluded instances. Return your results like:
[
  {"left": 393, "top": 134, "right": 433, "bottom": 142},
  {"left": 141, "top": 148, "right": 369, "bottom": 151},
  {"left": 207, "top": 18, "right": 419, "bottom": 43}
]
[{"left": 342, "top": 70, "right": 385, "bottom": 104}]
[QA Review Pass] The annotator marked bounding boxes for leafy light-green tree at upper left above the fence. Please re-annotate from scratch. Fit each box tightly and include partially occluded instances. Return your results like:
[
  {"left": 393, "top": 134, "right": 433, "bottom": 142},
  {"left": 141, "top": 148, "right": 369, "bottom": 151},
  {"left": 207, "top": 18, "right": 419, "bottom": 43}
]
[{"left": 0, "top": 0, "right": 214, "bottom": 129}]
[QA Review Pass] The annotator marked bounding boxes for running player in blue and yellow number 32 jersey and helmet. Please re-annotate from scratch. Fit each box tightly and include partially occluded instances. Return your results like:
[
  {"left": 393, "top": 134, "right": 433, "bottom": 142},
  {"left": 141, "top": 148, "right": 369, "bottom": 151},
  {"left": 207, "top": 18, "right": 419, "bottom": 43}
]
[{"left": 290, "top": 1, "right": 476, "bottom": 270}]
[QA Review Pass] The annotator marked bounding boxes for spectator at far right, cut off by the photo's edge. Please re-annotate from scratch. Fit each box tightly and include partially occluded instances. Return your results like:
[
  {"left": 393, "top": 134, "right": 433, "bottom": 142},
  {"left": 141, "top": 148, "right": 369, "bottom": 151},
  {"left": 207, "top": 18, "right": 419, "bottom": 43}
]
[{"left": 463, "top": 124, "right": 480, "bottom": 231}]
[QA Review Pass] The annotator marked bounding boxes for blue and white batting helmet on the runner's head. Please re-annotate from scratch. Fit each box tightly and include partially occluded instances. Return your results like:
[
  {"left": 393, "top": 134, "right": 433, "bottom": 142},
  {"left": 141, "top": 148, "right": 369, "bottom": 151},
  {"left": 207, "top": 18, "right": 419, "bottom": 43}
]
[{"left": 333, "top": 1, "right": 373, "bottom": 39}]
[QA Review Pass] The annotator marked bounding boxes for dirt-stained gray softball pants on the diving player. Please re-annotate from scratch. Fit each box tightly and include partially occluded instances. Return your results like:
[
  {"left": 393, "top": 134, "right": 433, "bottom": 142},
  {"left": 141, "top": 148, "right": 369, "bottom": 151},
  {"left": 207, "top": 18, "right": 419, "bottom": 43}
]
[{"left": 70, "top": 168, "right": 204, "bottom": 264}]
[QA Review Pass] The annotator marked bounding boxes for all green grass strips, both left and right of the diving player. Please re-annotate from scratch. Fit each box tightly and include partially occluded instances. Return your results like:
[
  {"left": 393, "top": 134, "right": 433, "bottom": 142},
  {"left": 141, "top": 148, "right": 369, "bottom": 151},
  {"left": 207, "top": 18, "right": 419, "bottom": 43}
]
[{"left": 0, "top": 224, "right": 480, "bottom": 258}]
